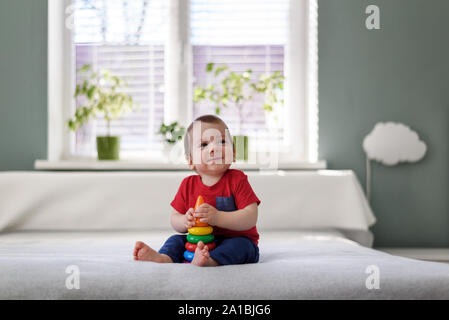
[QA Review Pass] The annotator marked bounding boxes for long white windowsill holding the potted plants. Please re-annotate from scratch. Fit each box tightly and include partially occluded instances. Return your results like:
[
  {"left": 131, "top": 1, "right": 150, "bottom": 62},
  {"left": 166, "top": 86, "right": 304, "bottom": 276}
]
[{"left": 34, "top": 159, "right": 327, "bottom": 171}]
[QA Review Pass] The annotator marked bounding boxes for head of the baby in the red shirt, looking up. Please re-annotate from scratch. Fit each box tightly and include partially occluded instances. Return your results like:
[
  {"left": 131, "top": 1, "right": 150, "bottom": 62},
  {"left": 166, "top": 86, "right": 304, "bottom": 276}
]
[{"left": 184, "top": 115, "right": 235, "bottom": 175}]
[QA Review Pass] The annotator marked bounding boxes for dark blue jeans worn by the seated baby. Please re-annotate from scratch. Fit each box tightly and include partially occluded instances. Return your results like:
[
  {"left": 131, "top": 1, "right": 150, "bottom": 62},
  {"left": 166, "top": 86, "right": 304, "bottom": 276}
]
[{"left": 159, "top": 234, "right": 259, "bottom": 265}]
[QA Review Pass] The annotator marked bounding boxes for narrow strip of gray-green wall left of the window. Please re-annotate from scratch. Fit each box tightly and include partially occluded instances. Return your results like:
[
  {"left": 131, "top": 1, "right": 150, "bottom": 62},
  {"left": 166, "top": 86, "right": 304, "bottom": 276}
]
[{"left": 0, "top": 0, "right": 47, "bottom": 170}]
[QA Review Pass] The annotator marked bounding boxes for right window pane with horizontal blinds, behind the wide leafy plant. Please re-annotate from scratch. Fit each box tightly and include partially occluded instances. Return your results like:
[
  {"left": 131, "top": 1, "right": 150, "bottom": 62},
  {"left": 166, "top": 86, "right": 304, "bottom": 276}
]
[{"left": 190, "top": 0, "right": 289, "bottom": 148}]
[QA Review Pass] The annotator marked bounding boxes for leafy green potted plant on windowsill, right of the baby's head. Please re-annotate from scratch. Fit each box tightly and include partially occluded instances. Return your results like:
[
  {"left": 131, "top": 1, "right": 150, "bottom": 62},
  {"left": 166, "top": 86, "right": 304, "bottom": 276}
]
[{"left": 194, "top": 62, "right": 284, "bottom": 161}]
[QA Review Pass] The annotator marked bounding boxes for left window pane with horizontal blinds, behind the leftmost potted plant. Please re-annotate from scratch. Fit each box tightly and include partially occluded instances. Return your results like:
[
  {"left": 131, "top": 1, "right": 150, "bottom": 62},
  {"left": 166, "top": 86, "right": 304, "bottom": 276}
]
[{"left": 73, "top": 0, "right": 167, "bottom": 157}]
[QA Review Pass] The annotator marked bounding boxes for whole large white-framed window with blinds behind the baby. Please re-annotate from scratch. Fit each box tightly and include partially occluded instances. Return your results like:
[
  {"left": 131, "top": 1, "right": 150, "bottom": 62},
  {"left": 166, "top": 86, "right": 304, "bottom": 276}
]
[{"left": 48, "top": 0, "right": 317, "bottom": 162}]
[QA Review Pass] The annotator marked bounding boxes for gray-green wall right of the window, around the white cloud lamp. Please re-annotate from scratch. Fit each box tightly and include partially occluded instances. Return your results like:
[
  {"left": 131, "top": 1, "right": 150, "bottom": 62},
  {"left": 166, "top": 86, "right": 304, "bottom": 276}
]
[{"left": 319, "top": 0, "right": 449, "bottom": 246}]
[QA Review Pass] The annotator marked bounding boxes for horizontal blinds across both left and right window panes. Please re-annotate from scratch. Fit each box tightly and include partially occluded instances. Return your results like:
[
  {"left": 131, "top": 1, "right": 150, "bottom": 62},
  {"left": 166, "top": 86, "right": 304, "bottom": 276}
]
[{"left": 73, "top": 0, "right": 289, "bottom": 156}]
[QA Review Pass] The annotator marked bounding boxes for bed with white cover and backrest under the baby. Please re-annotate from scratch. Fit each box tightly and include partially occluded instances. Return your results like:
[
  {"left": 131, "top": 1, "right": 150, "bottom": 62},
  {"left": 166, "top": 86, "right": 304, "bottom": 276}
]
[{"left": 0, "top": 171, "right": 449, "bottom": 300}]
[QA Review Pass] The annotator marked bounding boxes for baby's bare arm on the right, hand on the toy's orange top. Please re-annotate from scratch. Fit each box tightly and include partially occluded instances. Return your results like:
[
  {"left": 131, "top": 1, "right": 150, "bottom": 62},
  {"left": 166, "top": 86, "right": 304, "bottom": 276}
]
[{"left": 194, "top": 202, "right": 257, "bottom": 231}]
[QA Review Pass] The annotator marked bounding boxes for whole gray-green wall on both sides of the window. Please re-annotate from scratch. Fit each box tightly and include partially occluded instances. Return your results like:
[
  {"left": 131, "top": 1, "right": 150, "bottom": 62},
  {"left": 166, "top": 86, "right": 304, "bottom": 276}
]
[{"left": 0, "top": 0, "right": 449, "bottom": 246}]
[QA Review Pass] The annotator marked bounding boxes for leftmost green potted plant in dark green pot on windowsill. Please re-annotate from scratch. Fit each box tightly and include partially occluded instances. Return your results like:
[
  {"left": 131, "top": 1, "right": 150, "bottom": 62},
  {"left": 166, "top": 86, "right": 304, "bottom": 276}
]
[{"left": 67, "top": 65, "right": 136, "bottom": 160}]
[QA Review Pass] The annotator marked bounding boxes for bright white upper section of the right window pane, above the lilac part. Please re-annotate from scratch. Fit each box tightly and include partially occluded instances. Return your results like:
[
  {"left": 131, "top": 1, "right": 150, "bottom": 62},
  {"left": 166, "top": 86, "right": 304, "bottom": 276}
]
[{"left": 190, "top": 0, "right": 290, "bottom": 45}]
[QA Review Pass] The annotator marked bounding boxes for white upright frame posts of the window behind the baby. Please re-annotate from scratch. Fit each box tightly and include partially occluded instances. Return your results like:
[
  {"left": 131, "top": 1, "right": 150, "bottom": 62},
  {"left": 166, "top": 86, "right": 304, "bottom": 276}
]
[{"left": 47, "top": 0, "right": 319, "bottom": 167}]
